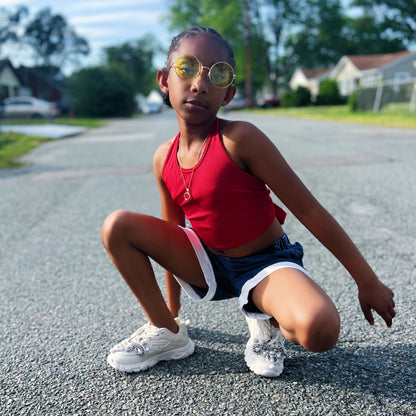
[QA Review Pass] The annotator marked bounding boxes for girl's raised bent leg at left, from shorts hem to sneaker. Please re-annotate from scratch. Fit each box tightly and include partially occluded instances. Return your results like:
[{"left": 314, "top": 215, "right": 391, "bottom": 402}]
[{"left": 101, "top": 210, "right": 207, "bottom": 333}]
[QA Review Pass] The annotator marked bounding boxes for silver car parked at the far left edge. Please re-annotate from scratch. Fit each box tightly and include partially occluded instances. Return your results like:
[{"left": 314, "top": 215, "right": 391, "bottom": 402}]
[{"left": 3, "top": 97, "right": 58, "bottom": 118}]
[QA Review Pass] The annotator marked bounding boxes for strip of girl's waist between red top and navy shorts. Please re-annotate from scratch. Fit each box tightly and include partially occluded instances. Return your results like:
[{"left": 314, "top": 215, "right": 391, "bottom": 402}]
[{"left": 209, "top": 219, "right": 283, "bottom": 257}]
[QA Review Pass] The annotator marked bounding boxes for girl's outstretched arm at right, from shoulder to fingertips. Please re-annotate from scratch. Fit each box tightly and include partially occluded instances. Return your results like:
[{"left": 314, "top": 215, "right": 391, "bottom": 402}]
[{"left": 224, "top": 123, "right": 395, "bottom": 326}]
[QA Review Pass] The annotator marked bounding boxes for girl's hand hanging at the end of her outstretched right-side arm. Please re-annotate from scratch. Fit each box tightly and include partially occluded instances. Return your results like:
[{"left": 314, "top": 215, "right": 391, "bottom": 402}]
[{"left": 358, "top": 280, "right": 396, "bottom": 327}]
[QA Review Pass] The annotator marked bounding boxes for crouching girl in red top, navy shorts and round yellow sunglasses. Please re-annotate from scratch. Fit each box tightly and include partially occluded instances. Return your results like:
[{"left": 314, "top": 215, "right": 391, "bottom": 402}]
[{"left": 101, "top": 27, "right": 395, "bottom": 377}]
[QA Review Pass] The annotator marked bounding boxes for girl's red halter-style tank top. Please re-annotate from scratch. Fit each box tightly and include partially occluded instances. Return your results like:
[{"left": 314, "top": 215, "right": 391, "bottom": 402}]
[{"left": 162, "top": 119, "right": 286, "bottom": 250}]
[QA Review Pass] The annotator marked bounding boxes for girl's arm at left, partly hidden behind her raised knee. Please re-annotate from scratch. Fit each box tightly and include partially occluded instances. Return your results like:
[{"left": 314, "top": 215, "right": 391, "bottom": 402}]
[{"left": 153, "top": 142, "right": 185, "bottom": 318}]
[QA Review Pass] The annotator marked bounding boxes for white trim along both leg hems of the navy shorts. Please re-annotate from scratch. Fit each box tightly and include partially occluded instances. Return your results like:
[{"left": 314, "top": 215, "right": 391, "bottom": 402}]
[{"left": 175, "top": 227, "right": 310, "bottom": 319}]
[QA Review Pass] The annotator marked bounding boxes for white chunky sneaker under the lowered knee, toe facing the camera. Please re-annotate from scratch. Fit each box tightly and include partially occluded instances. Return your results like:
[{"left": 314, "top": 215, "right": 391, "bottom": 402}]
[{"left": 244, "top": 316, "right": 287, "bottom": 377}]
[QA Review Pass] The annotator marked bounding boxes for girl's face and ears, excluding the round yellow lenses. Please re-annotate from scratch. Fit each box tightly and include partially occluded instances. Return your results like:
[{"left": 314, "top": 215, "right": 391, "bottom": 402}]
[{"left": 158, "top": 34, "right": 235, "bottom": 122}]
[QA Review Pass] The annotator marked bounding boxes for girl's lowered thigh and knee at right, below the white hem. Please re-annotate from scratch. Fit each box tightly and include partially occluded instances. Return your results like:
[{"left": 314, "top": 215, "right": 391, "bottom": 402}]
[{"left": 252, "top": 268, "right": 340, "bottom": 352}]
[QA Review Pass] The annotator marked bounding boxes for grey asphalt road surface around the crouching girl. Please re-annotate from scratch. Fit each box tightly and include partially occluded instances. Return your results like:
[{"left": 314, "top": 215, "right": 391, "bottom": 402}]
[{"left": 0, "top": 112, "right": 416, "bottom": 416}]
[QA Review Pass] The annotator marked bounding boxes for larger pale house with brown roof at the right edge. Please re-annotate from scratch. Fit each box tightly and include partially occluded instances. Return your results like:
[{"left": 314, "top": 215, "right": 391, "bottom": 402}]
[{"left": 330, "top": 50, "right": 416, "bottom": 96}]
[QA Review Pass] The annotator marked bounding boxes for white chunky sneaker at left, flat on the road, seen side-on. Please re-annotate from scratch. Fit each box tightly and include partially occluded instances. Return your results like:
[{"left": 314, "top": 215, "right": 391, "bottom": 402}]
[{"left": 107, "top": 320, "right": 195, "bottom": 373}]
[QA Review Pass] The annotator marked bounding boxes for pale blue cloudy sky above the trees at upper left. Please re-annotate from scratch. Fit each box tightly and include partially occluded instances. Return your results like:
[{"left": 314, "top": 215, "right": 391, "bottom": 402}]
[{"left": 0, "top": 0, "right": 171, "bottom": 71}]
